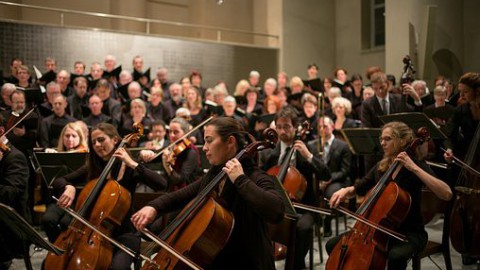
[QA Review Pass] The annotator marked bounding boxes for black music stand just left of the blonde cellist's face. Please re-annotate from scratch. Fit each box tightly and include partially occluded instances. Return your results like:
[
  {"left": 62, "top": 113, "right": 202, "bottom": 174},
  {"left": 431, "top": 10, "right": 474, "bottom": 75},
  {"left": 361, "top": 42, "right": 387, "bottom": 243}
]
[{"left": 340, "top": 128, "right": 383, "bottom": 155}]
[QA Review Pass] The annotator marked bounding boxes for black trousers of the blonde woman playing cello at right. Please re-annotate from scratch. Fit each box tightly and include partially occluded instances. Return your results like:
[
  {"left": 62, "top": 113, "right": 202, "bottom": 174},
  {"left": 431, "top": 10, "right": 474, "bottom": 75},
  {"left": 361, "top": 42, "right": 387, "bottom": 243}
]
[{"left": 325, "top": 230, "right": 428, "bottom": 270}]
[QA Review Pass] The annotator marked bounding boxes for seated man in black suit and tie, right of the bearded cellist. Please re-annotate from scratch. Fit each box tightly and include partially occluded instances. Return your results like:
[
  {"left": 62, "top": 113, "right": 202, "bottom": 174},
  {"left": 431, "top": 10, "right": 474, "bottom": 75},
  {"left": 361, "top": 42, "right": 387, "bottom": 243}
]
[{"left": 308, "top": 117, "right": 353, "bottom": 237}]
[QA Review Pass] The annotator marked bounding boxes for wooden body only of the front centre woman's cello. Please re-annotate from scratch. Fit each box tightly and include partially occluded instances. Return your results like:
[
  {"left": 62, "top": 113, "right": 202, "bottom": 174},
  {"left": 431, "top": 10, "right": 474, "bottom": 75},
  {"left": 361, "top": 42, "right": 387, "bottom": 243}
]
[{"left": 141, "top": 197, "right": 234, "bottom": 270}]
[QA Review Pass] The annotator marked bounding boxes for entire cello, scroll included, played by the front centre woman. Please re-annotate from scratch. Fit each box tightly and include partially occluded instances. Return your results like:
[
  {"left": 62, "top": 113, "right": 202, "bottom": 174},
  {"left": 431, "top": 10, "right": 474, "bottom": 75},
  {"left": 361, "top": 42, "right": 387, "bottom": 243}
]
[{"left": 138, "top": 127, "right": 276, "bottom": 269}]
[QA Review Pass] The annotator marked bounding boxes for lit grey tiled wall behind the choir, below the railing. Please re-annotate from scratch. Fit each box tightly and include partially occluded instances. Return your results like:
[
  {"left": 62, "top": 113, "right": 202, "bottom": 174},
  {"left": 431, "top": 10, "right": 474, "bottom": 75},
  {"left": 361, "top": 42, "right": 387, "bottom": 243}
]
[{"left": 0, "top": 22, "right": 278, "bottom": 88}]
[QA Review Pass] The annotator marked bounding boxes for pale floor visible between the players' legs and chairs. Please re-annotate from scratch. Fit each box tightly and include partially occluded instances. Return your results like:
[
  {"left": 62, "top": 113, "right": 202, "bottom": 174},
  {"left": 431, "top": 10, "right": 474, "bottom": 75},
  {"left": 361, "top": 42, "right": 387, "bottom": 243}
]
[{"left": 10, "top": 217, "right": 477, "bottom": 270}]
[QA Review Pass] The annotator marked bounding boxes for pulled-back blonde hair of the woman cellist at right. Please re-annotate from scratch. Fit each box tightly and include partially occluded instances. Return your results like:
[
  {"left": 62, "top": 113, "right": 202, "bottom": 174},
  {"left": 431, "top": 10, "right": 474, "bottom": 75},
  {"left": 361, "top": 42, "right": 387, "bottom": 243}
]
[{"left": 378, "top": 122, "right": 413, "bottom": 172}]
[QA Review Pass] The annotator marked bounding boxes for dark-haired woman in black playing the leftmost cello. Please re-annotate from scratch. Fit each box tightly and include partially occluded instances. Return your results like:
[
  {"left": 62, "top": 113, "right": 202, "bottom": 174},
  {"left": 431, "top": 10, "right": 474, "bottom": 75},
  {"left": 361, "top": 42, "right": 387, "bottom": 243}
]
[{"left": 46, "top": 123, "right": 166, "bottom": 269}]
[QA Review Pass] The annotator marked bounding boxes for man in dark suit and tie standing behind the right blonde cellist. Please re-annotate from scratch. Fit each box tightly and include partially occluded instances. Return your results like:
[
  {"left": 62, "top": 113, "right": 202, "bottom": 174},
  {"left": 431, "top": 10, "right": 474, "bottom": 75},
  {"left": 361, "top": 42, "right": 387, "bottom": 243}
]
[{"left": 361, "top": 72, "right": 422, "bottom": 128}]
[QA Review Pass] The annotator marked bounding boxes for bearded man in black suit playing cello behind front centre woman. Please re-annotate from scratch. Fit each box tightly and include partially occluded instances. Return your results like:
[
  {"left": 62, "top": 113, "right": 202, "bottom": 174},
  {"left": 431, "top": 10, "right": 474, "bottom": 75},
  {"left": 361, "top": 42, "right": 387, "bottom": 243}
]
[{"left": 260, "top": 107, "right": 331, "bottom": 269}]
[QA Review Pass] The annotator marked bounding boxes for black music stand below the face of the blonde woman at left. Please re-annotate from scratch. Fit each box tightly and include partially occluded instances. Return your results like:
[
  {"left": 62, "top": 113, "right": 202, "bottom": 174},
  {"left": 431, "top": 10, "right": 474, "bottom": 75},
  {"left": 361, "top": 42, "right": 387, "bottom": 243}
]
[{"left": 33, "top": 152, "right": 88, "bottom": 188}]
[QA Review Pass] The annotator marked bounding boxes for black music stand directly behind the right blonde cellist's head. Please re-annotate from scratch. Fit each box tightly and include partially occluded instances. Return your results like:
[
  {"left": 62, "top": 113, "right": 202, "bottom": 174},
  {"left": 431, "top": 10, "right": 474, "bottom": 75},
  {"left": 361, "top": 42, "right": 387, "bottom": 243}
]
[{"left": 378, "top": 112, "right": 447, "bottom": 140}]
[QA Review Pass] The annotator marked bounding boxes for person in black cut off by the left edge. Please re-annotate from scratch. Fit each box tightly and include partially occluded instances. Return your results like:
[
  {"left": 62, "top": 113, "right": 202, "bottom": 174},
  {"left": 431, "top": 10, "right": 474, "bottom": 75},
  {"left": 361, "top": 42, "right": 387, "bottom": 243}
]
[{"left": 0, "top": 115, "right": 30, "bottom": 269}]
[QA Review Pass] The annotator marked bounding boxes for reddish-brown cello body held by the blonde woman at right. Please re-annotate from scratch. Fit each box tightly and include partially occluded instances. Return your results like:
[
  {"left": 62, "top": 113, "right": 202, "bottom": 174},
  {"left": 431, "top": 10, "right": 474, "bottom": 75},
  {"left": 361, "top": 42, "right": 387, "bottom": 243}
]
[{"left": 325, "top": 182, "right": 411, "bottom": 270}]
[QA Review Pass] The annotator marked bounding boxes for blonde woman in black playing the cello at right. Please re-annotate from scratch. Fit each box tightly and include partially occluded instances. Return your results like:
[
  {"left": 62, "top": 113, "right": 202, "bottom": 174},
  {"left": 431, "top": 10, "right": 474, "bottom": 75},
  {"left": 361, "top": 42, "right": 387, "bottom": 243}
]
[{"left": 326, "top": 122, "right": 452, "bottom": 269}]
